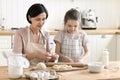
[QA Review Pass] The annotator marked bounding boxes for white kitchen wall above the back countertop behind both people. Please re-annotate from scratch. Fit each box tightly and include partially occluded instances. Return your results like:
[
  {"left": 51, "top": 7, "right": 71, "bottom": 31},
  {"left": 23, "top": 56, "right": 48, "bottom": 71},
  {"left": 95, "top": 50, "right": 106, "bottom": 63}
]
[{"left": 0, "top": 0, "right": 120, "bottom": 29}]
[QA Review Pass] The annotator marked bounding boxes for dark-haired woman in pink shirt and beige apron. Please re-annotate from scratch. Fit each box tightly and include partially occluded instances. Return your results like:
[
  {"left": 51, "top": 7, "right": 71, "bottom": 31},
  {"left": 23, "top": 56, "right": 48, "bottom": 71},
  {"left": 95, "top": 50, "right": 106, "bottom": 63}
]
[{"left": 13, "top": 4, "right": 58, "bottom": 64}]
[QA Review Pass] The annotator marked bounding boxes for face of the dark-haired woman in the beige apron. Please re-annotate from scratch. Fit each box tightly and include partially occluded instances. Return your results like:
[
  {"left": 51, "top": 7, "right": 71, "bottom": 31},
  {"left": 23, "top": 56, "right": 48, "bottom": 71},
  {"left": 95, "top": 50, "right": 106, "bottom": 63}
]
[{"left": 30, "top": 12, "right": 46, "bottom": 30}]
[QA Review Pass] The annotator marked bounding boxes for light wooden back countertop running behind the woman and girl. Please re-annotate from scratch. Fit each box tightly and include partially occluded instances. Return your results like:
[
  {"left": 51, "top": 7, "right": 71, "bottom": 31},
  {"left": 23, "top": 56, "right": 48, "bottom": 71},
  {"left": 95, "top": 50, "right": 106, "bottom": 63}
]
[{"left": 0, "top": 29, "right": 120, "bottom": 35}]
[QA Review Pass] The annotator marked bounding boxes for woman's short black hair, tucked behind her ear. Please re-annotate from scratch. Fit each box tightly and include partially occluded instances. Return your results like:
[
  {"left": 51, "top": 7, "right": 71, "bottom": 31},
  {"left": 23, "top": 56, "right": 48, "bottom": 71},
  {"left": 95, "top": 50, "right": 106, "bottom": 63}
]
[{"left": 26, "top": 3, "right": 48, "bottom": 23}]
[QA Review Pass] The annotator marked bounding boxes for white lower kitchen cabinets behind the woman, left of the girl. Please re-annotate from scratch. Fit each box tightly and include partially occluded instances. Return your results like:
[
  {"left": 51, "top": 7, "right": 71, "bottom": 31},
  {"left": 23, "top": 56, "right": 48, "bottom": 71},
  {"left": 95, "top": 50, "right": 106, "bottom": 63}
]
[{"left": 0, "top": 35, "right": 55, "bottom": 66}]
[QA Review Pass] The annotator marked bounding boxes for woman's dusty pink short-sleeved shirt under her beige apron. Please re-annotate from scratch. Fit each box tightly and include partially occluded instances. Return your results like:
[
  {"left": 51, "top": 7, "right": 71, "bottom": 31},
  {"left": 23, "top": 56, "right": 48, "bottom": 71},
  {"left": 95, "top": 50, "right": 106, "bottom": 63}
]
[{"left": 13, "top": 27, "right": 49, "bottom": 54}]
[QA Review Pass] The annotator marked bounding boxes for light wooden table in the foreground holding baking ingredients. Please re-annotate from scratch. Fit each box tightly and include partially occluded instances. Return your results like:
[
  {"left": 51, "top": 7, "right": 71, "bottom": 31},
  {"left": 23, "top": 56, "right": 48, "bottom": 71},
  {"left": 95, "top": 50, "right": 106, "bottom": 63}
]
[{"left": 0, "top": 62, "right": 120, "bottom": 80}]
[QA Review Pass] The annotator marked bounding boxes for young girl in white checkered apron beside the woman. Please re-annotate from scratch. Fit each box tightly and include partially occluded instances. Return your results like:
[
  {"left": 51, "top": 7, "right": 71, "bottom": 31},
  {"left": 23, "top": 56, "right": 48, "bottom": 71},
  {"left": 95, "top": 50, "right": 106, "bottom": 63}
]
[{"left": 54, "top": 9, "right": 88, "bottom": 62}]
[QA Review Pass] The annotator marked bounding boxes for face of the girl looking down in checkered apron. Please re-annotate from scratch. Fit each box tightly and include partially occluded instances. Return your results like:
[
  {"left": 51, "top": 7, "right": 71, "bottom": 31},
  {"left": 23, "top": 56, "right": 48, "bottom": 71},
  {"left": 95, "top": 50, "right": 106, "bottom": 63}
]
[{"left": 65, "top": 19, "right": 79, "bottom": 33}]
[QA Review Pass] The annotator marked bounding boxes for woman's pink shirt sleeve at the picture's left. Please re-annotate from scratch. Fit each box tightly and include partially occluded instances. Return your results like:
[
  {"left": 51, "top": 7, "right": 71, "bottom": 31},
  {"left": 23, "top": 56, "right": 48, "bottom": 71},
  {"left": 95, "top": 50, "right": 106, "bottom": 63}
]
[{"left": 13, "top": 31, "right": 23, "bottom": 53}]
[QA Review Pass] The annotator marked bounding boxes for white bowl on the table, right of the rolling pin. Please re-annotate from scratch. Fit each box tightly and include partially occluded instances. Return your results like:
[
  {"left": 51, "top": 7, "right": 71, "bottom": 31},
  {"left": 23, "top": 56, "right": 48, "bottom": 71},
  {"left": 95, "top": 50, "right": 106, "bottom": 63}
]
[{"left": 88, "top": 63, "right": 104, "bottom": 73}]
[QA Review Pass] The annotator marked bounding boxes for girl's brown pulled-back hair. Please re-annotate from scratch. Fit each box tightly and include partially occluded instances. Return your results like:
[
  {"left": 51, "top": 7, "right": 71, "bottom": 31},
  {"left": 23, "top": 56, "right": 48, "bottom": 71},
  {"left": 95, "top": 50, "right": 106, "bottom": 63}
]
[{"left": 64, "top": 8, "right": 81, "bottom": 24}]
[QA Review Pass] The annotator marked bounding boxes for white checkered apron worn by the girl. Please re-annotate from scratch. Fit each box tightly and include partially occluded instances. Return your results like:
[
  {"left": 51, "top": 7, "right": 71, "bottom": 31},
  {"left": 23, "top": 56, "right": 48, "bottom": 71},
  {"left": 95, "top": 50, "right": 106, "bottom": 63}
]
[{"left": 61, "top": 32, "right": 83, "bottom": 61}]
